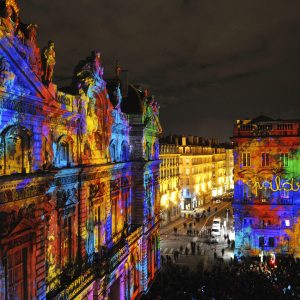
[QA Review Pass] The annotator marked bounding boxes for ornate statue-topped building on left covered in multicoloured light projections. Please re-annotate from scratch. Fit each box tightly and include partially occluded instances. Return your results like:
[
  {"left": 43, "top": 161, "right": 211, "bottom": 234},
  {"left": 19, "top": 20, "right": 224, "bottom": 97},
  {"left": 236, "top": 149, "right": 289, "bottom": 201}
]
[{"left": 0, "top": 0, "right": 161, "bottom": 299}]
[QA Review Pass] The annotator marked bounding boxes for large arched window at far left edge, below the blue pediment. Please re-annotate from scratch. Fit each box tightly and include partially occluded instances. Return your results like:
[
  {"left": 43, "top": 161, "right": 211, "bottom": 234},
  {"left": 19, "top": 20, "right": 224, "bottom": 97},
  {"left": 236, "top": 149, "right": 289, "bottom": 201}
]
[{"left": 0, "top": 126, "right": 32, "bottom": 175}]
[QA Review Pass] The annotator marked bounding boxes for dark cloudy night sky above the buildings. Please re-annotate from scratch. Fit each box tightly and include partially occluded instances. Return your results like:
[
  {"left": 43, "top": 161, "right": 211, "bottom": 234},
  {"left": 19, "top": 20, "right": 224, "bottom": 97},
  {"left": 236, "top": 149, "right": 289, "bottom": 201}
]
[{"left": 18, "top": 0, "right": 300, "bottom": 139}]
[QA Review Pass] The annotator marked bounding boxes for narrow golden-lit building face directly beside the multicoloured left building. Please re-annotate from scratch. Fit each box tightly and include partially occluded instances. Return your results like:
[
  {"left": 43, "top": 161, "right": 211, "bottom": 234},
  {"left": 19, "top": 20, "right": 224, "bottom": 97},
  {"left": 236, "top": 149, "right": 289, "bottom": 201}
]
[{"left": 159, "top": 137, "right": 180, "bottom": 225}]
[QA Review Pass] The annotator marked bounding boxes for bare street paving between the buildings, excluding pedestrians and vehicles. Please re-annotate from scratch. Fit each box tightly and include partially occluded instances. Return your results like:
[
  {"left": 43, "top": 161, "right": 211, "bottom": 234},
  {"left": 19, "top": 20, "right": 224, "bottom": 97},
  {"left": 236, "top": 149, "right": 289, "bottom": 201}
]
[{"left": 160, "top": 202, "right": 234, "bottom": 269}]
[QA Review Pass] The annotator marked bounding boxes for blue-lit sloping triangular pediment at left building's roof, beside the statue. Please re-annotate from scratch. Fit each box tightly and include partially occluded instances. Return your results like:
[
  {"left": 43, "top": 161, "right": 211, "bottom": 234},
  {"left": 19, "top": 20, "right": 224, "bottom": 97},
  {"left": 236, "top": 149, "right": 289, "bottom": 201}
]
[{"left": 0, "top": 34, "right": 53, "bottom": 101}]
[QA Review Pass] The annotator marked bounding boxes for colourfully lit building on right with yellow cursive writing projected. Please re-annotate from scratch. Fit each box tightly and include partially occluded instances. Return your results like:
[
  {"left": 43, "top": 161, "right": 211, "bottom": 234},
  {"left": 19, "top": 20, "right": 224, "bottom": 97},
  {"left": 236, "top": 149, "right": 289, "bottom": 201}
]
[{"left": 232, "top": 116, "right": 300, "bottom": 257}]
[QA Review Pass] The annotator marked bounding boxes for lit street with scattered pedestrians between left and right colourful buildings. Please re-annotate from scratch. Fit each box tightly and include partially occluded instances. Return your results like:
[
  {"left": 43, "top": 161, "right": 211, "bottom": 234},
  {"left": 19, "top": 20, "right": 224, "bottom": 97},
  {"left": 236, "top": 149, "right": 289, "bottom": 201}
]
[{"left": 160, "top": 202, "right": 234, "bottom": 270}]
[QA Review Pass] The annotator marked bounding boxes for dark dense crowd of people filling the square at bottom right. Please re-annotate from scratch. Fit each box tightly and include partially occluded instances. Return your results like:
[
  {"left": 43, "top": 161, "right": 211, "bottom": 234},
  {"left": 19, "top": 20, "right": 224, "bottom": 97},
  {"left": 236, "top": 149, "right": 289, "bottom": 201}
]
[{"left": 143, "top": 257, "right": 300, "bottom": 300}]
